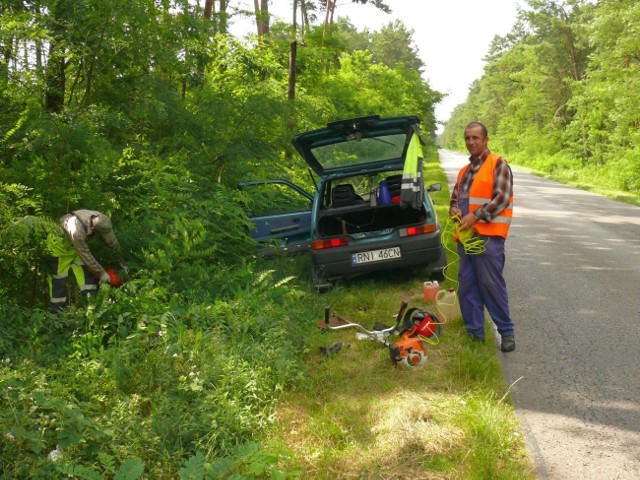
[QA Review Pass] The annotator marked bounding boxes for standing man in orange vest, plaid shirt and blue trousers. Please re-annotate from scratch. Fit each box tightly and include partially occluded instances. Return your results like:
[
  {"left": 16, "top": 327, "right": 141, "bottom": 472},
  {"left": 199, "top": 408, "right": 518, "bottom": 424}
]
[{"left": 449, "top": 122, "right": 516, "bottom": 352}]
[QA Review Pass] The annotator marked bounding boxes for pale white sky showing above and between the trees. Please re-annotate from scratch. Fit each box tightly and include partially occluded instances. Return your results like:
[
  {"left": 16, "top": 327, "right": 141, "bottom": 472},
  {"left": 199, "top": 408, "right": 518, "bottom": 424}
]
[{"left": 229, "top": 0, "right": 525, "bottom": 129}]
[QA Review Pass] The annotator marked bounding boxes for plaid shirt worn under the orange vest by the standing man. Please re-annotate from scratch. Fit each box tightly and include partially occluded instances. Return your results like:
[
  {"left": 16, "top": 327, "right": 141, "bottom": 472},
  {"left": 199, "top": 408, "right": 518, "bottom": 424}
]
[{"left": 449, "top": 150, "right": 513, "bottom": 222}]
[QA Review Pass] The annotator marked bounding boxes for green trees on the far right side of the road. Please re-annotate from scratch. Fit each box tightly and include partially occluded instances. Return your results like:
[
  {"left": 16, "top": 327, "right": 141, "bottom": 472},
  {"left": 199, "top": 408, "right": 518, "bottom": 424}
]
[{"left": 441, "top": 0, "right": 640, "bottom": 196}]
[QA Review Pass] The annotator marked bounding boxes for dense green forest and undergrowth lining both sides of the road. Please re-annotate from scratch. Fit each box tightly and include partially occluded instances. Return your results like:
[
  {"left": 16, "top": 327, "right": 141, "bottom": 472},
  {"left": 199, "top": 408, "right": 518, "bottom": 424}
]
[{"left": 0, "top": 0, "right": 640, "bottom": 479}]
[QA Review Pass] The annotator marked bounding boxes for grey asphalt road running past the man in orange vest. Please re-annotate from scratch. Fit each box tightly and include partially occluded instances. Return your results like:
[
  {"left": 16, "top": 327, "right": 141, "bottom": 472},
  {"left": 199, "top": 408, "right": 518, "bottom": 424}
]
[{"left": 440, "top": 150, "right": 640, "bottom": 480}]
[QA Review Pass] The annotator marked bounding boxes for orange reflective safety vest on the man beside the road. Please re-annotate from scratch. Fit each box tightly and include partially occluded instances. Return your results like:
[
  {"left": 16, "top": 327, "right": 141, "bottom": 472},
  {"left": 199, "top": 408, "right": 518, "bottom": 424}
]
[{"left": 458, "top": 153, "right": 513, "bottom": 238}]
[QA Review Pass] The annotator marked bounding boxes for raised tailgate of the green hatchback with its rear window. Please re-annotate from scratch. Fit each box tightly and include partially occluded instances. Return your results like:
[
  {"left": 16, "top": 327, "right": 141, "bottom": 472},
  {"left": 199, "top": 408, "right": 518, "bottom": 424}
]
[{"left": 291, "top": 115, "right": 420, "bottom": 176}]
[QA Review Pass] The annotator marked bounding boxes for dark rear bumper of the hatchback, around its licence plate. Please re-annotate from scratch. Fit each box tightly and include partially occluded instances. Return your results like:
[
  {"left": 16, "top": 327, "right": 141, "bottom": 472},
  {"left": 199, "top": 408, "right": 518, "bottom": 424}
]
[{"left": 311, "top": 231, "right": 446, "bottom": 280}]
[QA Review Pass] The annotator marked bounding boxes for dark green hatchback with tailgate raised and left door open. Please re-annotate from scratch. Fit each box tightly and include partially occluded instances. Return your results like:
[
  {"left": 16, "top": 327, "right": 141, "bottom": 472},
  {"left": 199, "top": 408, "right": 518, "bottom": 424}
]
[{"left": 241, "top": 115, "right": 446, "bottom": 290}]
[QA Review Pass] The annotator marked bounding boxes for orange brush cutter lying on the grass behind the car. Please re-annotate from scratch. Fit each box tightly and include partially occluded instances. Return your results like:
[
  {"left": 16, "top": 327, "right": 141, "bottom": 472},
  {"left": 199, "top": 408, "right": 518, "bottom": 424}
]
[{"left": 323, "top": 300, "right": 442, "bottom": 368}]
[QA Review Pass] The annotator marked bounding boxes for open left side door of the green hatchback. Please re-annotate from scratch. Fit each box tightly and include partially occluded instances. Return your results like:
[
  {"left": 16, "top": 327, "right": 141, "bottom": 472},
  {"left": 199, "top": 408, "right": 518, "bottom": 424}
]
[{"left": 238, "top": 179, "right": 313, "bottom": 256}]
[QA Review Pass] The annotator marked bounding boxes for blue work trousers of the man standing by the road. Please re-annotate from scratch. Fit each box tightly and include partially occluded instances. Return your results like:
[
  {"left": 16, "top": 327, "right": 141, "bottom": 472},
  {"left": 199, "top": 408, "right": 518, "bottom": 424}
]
[{"left": 458, "top": 236, "right": 513, "bottom": 338}]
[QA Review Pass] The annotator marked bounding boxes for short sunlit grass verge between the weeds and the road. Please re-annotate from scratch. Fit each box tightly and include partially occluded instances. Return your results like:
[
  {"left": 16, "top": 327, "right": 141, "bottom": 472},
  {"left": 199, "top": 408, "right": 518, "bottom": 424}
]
[{"left": 272, "top": 156, "right": 534, "bottom": 479}]
